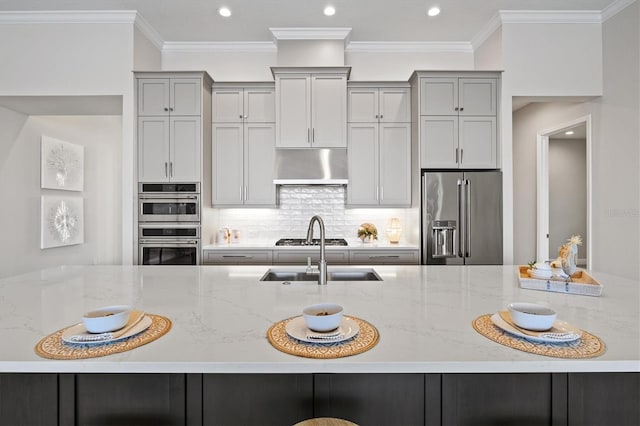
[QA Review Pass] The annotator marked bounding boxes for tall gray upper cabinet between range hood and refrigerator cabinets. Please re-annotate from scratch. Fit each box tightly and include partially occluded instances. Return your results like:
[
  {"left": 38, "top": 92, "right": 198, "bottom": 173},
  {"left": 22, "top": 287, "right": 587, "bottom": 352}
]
[{"left": 347, "top": 83, "right": 411, "bottom": 207}]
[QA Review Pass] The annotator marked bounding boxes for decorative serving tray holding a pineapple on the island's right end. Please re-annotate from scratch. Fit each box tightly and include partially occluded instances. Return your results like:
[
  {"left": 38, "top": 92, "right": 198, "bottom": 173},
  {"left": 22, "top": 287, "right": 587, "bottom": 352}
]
[{"left": 518, "top": 265, "right": 603, "bottom": 296}]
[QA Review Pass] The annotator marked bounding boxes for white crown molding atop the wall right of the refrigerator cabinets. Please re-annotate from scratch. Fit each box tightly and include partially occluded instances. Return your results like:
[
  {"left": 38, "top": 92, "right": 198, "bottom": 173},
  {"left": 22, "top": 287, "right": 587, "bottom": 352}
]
[{"left": 498, "top": 10, "right": 602, "bottom": 24}]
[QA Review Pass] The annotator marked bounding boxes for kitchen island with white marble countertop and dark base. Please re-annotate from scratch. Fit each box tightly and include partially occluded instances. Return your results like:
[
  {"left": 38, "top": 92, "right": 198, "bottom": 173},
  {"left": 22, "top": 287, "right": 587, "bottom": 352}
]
[{"left": 0, "top": 265, "right": 640, "bottom": 425}]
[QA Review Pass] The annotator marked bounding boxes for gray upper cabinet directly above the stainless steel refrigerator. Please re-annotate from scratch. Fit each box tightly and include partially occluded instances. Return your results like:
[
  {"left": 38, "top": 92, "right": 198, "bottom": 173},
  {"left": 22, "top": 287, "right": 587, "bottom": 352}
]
[{"left": 412, "top": 72, "right": 500, "bottom": 169}]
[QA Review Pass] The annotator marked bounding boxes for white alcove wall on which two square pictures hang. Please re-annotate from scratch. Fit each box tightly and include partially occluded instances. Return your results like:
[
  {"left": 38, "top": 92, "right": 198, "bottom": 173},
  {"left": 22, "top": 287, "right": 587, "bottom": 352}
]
[{"left": 0, "top": 107, "right": 122, "bottom": 277}]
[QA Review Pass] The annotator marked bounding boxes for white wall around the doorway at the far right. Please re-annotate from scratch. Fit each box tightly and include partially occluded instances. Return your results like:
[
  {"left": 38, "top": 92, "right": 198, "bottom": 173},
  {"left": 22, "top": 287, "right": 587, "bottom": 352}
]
[{"left": 513, "top": 2, "right": 640, "bottom": 279}]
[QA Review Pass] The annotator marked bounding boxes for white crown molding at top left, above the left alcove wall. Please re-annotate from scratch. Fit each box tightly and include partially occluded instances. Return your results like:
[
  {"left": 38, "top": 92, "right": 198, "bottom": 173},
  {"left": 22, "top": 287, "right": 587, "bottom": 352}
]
[{"left": 0, "top": 10, "right": 138, "bottom": 24}]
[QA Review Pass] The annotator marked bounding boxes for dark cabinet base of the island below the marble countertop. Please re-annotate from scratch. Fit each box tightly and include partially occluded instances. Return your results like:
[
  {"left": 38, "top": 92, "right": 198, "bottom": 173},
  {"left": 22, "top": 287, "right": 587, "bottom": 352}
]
[{"left": 0, "top": 373, "right": 640, "bottom": 426}]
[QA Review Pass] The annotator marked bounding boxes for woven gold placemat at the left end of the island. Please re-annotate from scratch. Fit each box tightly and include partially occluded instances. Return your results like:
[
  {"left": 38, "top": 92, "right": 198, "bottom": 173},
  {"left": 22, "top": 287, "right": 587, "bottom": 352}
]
[{"left": 35, "top": 314, "right": 171, "bottom": 359}]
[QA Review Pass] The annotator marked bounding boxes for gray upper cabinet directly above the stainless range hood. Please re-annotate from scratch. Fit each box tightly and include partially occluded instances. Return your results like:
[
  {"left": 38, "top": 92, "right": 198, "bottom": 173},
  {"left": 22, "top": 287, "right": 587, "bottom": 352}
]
[{"left": 272, "top": 67, "right": 350, "bottom": 148}]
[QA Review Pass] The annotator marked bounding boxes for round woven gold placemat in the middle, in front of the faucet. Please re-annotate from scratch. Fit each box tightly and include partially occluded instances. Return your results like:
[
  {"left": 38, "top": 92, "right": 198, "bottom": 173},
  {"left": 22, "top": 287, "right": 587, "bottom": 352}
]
[{"left": 267, "top": 316, "right": 380, "bottom": 359}]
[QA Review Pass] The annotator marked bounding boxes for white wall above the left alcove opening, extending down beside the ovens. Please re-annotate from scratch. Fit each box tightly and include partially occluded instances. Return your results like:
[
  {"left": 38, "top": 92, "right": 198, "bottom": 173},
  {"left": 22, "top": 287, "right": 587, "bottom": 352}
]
[{"left": 0, "top": 19, "right": 135, "bottom": 270}]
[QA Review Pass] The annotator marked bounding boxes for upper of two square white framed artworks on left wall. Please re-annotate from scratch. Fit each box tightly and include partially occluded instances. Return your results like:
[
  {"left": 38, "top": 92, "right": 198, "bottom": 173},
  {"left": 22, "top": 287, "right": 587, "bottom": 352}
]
[{"left": 40, "top": 135, "right": 84, "bottom": 191}]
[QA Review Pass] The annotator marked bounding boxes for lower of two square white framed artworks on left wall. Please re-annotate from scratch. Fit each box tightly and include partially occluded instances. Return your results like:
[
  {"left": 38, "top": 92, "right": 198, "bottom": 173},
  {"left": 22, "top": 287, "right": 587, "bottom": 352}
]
[{"left": 40, "top": 195, "right": 84, "bottom": 249}]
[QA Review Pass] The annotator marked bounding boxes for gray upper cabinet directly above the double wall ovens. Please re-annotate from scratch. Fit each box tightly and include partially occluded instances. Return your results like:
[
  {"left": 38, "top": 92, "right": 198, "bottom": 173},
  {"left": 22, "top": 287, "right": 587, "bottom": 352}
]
[{"left": 136, "top": 72, "right": 213, "bottom": 182}]
